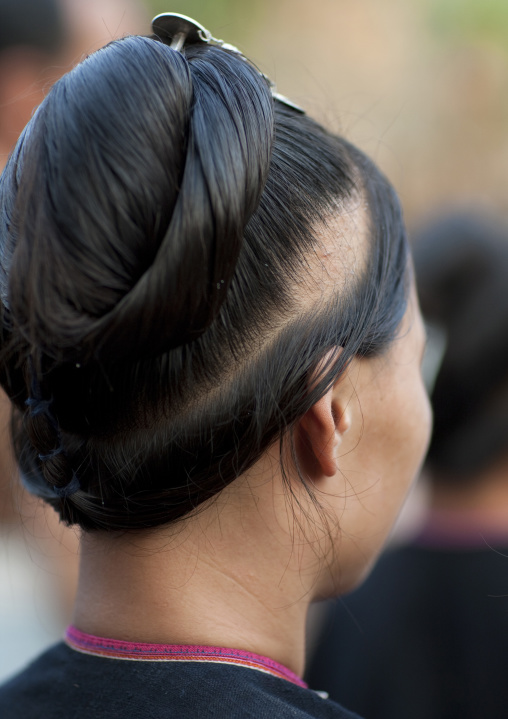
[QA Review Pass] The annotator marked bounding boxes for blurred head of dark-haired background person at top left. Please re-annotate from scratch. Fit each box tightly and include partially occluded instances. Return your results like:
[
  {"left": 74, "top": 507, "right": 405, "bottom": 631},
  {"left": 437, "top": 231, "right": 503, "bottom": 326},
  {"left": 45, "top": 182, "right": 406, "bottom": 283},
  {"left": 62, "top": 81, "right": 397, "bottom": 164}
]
[{"left": 0, "top": 0, "right": 147, "bottom": 170}]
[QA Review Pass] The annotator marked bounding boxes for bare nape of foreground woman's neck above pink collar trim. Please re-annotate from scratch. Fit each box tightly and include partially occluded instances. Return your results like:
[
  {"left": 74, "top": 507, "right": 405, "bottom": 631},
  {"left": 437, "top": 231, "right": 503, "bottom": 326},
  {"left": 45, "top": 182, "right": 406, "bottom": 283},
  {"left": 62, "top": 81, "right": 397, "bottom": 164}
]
[{"left": 73, "top": 480, "right": 316, "bottom": 676}]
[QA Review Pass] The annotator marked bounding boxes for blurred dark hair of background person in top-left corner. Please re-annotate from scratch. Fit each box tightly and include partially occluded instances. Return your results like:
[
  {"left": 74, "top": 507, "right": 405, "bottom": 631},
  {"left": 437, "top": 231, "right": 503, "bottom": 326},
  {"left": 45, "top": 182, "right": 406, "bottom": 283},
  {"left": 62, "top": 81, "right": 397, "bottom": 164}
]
[{"left": 0, "top": 0, "right": 66, "bottom": 55}]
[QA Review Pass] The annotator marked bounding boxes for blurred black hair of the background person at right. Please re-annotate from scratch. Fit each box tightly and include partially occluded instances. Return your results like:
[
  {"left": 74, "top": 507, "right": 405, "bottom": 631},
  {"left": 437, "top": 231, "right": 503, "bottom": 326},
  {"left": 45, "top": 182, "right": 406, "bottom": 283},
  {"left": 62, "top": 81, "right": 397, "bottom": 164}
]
[{"left": 414, "top": 212, "right": 508, "bottom": 484}]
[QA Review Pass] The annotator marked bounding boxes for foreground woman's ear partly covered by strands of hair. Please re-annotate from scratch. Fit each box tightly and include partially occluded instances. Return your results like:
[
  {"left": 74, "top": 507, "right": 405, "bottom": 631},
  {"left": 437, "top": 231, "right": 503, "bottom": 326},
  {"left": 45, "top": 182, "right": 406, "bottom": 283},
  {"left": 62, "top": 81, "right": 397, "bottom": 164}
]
[{"left": 296, "top": 378, "right": 351, "bottom": 482}]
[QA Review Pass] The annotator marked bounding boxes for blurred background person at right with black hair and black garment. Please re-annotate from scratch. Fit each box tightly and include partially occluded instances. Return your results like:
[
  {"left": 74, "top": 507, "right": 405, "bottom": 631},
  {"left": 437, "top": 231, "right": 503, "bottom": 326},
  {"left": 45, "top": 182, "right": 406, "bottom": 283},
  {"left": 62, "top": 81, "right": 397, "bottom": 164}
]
[{"left": 306, "top": 215, "right": 508, "bottom": 719}]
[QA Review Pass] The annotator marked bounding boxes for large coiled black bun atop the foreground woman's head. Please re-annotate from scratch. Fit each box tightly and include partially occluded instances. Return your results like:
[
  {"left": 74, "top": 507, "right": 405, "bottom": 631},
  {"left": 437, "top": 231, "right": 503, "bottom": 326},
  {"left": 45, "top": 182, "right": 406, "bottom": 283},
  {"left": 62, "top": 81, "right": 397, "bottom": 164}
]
[{"left": 0, "top": 37, "right": 273, "bottom": 362}]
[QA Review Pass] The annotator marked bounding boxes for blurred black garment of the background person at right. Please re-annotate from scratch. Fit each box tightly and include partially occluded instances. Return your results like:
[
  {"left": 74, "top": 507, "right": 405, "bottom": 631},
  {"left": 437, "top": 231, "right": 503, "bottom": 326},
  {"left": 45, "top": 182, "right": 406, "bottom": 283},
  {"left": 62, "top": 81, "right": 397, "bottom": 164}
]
[{"left": 306, "top": 544, "right": 508, "bottom": 719}]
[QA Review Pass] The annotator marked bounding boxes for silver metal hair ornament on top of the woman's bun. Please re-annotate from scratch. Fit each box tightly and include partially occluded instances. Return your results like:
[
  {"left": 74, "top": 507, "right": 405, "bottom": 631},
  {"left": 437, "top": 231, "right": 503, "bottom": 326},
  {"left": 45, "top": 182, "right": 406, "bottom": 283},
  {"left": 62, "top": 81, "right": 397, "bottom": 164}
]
[{"left": 152, "top": 12, "right": 305, "bottom": 115}]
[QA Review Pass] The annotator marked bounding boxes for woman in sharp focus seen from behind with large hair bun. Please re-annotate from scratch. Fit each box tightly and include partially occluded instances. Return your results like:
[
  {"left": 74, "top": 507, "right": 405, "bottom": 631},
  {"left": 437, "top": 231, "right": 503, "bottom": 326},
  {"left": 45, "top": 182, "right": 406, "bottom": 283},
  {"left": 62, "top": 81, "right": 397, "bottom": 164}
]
[{"left": 0, "top": 15, "right": 429, "bottom": 718}]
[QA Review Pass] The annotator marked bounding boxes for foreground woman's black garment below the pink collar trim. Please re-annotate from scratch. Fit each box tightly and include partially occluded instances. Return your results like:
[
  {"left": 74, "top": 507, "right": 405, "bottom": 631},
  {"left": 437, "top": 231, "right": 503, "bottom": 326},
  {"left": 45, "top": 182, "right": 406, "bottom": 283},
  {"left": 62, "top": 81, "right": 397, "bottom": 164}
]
[{"left": 0, "top": 643, "right": 358, "bottom": 719}]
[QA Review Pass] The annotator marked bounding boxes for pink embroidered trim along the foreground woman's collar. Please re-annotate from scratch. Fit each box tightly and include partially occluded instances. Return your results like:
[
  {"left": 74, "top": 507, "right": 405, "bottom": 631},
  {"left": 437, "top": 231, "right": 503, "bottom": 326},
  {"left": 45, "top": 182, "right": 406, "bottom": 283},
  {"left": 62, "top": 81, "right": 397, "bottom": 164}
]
[{"left": 65, "top": 626, "right": 308, "bottom": 689}]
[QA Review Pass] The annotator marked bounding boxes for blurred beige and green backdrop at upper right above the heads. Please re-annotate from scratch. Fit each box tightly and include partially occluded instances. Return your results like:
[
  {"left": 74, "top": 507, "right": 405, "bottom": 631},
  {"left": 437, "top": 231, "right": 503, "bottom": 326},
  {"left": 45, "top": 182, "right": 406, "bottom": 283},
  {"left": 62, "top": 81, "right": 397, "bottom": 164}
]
[{"left": 149, "top": 0, "right": 508, "bottom": 225}]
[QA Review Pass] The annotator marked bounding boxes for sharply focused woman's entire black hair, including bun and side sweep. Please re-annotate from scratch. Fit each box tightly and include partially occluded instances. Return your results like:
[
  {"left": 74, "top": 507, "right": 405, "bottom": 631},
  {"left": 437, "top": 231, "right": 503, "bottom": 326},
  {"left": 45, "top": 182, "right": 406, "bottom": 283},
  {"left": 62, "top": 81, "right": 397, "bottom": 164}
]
[{"left": 0, "top": 37, "right": 408, "bottom": 530}]
